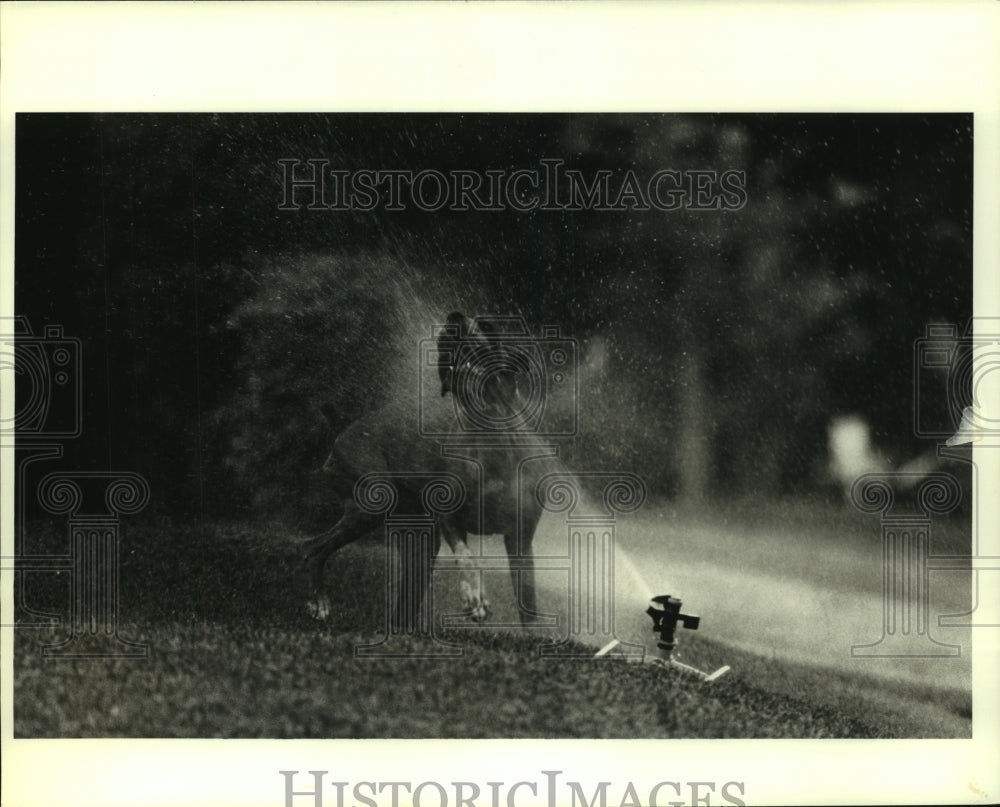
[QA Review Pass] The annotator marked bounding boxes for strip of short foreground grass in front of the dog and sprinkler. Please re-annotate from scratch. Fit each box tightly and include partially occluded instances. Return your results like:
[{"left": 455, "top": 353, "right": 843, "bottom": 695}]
[{"left": 15, "top": 623, "right": 928, "bottom": 738}]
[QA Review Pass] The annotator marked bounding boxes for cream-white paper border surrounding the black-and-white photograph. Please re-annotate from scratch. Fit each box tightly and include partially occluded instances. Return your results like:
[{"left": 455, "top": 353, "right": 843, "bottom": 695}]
[{"left": 0, "top": 1, "right": 1000, "bottom": 807}]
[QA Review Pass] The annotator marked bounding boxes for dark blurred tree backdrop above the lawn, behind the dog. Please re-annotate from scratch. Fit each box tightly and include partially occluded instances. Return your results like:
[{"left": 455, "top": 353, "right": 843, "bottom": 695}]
[{"left": 15, "top": 114, "right": 973, "bottom": 529}]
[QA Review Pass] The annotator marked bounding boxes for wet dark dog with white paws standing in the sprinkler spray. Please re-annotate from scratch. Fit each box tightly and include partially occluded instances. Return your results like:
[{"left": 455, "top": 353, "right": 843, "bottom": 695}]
[{"left": 306, "top": 313, "right": 557, "bottom": 623}]
